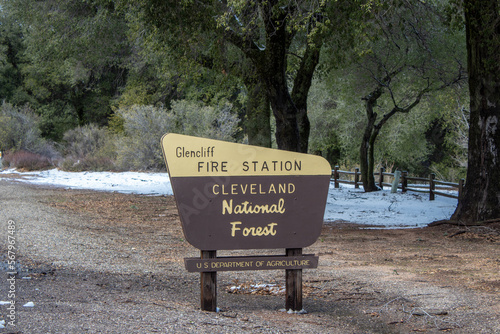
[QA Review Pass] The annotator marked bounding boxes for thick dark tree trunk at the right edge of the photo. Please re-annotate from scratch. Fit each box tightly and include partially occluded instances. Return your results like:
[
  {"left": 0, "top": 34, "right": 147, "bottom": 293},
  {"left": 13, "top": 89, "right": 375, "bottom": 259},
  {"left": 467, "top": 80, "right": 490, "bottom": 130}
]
[{"left": 451, "top": 0, "right": 500, "bottom": 224}]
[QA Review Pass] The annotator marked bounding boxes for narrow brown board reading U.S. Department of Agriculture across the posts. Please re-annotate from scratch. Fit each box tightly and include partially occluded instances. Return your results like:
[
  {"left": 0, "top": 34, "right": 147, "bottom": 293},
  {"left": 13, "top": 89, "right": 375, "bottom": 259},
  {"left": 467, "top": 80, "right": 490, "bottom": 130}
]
[{"left": 184, "top": 254, "right": 318, "bottom": 272}]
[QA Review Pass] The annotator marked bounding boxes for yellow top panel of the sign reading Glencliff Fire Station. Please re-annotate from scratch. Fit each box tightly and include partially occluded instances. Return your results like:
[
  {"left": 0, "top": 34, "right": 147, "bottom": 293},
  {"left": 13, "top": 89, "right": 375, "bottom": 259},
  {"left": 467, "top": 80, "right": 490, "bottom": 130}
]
[{"left": 162, "top": 133, "right": 331, "bottom": 177}]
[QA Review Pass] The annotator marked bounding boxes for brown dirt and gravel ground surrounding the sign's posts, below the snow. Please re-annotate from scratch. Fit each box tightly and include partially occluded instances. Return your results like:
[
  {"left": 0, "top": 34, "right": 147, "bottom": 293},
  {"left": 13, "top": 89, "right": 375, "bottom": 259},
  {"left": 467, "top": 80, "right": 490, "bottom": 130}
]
[{"left": 0, "top": 178, "right": 500, "bottom": 333}]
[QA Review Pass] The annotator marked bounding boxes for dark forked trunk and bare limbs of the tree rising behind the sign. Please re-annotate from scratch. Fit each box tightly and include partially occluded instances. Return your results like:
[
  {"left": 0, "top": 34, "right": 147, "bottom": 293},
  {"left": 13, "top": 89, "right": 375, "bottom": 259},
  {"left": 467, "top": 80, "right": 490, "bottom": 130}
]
[{"left": 223, "top": 0, "right": 322, "bottom": 152}]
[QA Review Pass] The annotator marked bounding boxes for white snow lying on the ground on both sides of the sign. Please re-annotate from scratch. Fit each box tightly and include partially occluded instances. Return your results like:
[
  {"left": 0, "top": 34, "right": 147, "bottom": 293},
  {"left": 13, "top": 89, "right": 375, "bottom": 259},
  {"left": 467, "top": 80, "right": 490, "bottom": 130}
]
[{"left": 0, "top": 169, "right": 457, "bottom": 228}]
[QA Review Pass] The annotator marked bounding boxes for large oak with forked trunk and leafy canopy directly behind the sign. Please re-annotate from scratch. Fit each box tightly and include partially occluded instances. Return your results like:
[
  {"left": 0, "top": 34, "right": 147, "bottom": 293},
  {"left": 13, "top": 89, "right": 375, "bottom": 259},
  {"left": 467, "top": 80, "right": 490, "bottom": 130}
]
[{"left": 124, "top": 0, "right": 358, "bottom": 152}]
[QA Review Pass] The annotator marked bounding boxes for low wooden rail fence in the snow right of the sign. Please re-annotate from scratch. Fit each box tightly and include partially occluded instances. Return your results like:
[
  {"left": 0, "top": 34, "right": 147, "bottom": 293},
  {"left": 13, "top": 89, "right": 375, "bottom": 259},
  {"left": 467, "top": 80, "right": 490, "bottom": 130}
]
[{"left": 332, "top": 166, "right": 465, "bottom": 201}]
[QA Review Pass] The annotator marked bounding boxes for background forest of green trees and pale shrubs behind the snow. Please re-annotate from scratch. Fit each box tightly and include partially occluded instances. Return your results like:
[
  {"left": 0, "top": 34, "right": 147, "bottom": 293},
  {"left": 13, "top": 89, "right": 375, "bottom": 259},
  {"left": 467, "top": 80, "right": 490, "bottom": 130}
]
[{"left": 0, "top": 0, "right": 469, "bottom": 181}]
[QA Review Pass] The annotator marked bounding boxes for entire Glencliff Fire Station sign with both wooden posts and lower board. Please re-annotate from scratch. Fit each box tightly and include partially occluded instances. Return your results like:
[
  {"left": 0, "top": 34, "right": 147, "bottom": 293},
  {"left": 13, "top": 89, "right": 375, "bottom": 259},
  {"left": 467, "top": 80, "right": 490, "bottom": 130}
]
[{"left": 162, "top": 134, "right": 331, "bottom": 311}]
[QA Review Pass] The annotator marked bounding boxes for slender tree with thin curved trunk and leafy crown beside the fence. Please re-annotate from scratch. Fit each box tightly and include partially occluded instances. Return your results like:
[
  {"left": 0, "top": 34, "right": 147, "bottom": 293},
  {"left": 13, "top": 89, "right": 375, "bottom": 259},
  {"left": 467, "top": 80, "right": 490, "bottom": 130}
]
[{"left": 354, "top": 0, "right": 466, "bottom": 192}]
